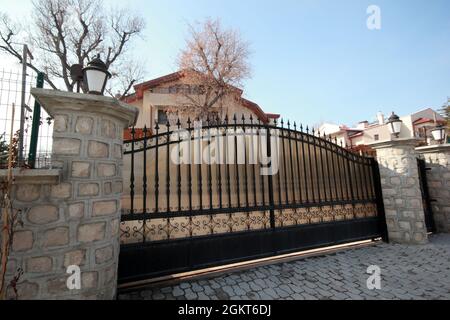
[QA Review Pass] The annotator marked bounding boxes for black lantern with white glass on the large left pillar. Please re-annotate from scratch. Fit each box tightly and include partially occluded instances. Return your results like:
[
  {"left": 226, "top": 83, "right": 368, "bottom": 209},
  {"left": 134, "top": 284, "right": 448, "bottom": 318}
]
[{"left": 83, "top": 55, "right": 111, "bottom": 95}]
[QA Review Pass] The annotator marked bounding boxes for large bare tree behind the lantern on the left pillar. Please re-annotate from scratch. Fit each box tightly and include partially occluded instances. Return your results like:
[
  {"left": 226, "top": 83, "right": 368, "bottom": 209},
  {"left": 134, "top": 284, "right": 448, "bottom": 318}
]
[{"left": 0, "top": 0, "right": 145, "bottom": 96}]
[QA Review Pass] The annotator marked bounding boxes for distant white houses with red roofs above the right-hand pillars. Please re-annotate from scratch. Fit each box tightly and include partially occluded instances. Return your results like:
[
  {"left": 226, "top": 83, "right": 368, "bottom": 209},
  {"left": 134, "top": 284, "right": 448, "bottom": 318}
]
[{"left": 319, "top": 108, "right": 445, "bottom": 151}]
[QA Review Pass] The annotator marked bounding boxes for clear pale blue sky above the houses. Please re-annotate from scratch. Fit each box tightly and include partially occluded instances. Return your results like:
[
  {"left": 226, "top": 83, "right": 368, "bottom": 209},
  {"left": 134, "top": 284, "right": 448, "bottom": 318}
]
[{"left": 0, "top": 0, "right": 450, "bottom": 125}]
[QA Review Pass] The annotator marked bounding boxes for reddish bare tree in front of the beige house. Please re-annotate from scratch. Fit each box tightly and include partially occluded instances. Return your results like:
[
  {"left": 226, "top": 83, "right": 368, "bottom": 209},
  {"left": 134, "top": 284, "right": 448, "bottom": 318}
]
[{"left": 178, "top": 19, "right": 251, "bottom": 116}]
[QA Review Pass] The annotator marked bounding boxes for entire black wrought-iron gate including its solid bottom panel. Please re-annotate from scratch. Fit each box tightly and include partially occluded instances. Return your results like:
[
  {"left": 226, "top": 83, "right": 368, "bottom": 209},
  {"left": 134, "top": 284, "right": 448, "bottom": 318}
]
[{"left": 119, "top": 117, "right": 386, "bottom": 283}]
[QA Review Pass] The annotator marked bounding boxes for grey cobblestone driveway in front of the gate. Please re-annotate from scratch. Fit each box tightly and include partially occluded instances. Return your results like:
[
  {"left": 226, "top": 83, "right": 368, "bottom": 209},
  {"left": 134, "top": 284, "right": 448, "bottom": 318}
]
[{"left": 119, "top": 234, "right": 450, "bottom": 300}]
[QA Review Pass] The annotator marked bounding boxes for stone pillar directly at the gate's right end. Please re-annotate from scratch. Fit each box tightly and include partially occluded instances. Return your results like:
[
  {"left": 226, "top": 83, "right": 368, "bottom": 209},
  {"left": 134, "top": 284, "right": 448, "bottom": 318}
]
[{"left": 371, "top": 139, "right": 427, "bottom": 244}]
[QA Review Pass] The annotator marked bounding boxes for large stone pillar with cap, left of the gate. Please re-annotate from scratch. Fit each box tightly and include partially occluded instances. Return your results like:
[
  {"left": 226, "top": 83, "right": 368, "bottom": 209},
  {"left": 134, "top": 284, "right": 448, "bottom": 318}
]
[{"left": 9, "top": 89, "right": 138, "bottom": 299}]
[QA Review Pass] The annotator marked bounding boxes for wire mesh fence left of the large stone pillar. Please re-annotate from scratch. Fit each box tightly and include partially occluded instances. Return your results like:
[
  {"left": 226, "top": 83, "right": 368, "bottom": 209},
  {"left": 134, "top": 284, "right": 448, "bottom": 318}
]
[{"left": 0, "top": 69, "right": 53, "bottom": 168}]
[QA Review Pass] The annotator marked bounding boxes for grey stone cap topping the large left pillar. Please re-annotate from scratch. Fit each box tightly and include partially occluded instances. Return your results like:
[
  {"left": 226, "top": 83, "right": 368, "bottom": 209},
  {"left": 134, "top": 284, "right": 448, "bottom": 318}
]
[{"left": 31, "top": 88, "right": 139, "bottom": 127}]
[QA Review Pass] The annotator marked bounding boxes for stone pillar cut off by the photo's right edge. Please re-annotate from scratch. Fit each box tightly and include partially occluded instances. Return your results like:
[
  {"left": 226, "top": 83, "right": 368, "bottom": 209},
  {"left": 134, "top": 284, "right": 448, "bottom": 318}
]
[{"left": 416, "top": 144, "right": 450, "bottom": 232}]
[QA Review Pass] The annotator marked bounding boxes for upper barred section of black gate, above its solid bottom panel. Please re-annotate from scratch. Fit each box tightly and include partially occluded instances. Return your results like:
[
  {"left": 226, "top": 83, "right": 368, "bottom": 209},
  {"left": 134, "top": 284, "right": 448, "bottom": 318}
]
[{"left": 122, "top": 119, "right": 384, "bottom": 242}]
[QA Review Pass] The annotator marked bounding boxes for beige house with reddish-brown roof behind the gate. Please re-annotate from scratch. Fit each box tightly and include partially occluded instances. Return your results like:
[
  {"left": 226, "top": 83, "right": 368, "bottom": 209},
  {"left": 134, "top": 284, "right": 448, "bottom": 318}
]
[{"left": 124, "top": 71, "right": 280, "bottom": 139}]
